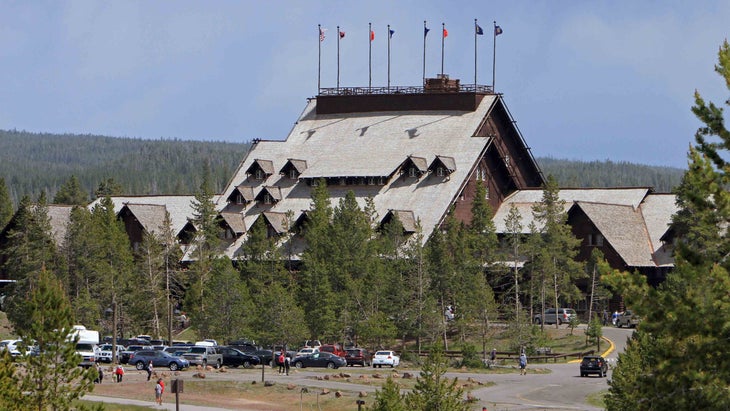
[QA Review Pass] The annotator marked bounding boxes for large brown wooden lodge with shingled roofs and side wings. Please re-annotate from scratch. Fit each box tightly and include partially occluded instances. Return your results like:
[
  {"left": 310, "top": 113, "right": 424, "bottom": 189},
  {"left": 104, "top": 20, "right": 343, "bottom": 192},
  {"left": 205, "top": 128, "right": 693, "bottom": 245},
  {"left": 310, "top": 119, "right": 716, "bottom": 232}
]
[{"left": 0, "top": 76, "right": 676, "bottom": 312}]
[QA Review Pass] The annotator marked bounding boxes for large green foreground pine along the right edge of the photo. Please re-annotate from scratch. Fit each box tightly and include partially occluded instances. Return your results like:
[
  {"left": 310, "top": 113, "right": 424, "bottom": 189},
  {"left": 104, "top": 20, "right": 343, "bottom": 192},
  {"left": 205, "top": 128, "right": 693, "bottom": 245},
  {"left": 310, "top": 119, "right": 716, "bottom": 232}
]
[{"left": 606, "top": 40, "right": 730, "bottom": 410}]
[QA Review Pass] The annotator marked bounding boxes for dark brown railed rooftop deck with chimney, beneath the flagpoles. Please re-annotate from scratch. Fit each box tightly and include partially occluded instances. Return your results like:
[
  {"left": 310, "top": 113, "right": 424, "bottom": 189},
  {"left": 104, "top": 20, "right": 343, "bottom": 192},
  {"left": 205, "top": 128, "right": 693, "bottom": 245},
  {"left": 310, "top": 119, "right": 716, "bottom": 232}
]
[{"left": 317, "top": 75, "right": 494, "bottom": 114}]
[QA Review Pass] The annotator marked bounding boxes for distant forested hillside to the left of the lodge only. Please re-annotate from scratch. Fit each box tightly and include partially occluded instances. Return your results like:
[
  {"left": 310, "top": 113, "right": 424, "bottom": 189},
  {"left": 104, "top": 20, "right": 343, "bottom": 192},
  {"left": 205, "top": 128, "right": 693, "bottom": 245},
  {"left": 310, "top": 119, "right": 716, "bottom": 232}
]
[{"left": 0, "top": 130, "right": 250, "bottom": 205}]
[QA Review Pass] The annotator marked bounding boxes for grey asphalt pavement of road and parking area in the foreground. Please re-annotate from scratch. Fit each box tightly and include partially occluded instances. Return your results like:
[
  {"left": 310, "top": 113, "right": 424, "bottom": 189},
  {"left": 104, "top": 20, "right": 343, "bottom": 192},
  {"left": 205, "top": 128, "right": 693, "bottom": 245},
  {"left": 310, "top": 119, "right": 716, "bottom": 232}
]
[{"left": 86, "top": 327, "right": 633, "bottom": 411}]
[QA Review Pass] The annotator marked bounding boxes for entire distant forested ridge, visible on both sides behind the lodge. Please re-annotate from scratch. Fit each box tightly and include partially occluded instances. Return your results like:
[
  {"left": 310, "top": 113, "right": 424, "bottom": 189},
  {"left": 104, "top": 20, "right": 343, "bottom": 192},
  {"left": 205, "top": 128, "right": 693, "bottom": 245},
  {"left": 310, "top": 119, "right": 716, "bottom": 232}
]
[{"left": 0, "top": 130, "right": 684, "bottom": 205}]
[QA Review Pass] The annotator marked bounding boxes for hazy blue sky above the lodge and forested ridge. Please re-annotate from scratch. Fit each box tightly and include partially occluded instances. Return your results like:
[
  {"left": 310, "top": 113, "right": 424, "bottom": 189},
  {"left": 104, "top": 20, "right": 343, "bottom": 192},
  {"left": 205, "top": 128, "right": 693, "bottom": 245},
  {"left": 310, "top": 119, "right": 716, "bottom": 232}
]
[{"left": 0, "top": 0, "right": 730, "bottom": 167}]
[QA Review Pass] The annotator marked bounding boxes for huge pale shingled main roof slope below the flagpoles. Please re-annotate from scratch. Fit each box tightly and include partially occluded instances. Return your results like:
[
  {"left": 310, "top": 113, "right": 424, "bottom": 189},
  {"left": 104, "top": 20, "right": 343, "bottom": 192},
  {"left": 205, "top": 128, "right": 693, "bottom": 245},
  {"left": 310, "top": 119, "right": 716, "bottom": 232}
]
[{"left": 218, "top": 94, "right": 502, "bottom": 246}]
